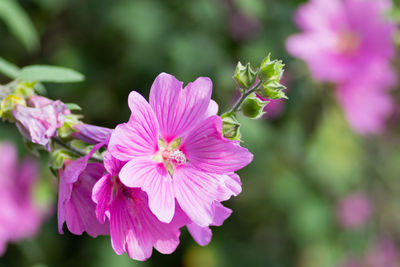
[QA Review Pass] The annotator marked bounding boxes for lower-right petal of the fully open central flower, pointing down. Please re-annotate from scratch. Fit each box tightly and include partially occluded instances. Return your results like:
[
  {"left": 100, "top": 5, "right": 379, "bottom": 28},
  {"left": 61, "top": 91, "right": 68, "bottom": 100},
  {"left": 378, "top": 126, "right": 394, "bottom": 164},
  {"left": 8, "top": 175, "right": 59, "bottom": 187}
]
[{"left": 173, "top": 164, "right": 222, "bottom": 226}]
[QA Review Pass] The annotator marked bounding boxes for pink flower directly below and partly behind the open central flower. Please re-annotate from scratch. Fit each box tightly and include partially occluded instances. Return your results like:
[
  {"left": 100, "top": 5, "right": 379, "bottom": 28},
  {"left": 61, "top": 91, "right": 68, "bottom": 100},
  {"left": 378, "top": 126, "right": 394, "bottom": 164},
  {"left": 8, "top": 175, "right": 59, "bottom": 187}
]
[{"left": 93, "top": 153, "right": 189, "bottom": 260}]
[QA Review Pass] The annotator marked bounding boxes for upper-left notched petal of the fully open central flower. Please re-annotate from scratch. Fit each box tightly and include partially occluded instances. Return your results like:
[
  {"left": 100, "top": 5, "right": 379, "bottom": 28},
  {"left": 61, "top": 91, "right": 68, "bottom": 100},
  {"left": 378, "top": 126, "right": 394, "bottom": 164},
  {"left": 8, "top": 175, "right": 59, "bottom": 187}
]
[{"left": 108, "top": 92, "right": 158, "bottom": 161}]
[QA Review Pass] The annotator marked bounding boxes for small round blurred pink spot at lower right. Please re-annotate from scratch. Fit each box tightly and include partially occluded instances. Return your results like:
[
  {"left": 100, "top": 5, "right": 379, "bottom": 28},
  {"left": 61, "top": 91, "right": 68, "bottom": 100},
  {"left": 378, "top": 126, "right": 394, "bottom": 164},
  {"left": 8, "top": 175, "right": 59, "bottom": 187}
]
[{"left": 337, "top": 193, "right": 372, "bottom": 229}]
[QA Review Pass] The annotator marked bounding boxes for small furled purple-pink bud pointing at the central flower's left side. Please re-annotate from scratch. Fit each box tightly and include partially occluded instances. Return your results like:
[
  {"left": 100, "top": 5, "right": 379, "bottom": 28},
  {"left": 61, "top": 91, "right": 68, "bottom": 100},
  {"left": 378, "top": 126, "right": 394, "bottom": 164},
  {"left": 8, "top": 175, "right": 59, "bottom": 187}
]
[{"left": 71, "top": 123, "right": 113, "bottom": 145}]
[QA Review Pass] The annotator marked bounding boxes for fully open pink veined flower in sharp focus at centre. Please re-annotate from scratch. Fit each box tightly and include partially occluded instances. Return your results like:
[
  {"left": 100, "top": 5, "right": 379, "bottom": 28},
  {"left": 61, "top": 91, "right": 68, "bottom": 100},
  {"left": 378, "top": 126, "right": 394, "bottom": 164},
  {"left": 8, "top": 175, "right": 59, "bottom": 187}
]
[{"left": 108, "top": 73, "right": 252, "bottom": 227}]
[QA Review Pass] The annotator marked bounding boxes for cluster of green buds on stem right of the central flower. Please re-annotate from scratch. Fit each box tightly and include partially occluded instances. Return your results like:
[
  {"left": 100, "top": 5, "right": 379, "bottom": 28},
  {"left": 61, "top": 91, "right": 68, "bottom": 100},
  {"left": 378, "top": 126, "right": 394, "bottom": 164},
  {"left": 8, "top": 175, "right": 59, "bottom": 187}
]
[{"left": 222, "top": 54, "right": 287, "bottom": 140}]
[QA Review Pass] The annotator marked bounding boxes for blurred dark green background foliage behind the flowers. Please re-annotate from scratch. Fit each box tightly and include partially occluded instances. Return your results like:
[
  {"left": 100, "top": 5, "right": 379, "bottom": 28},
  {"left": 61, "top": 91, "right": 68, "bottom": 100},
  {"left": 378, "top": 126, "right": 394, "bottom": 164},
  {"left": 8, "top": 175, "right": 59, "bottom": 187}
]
[{"left": 0, "top": 0, "right": 400, "bottom": 267}]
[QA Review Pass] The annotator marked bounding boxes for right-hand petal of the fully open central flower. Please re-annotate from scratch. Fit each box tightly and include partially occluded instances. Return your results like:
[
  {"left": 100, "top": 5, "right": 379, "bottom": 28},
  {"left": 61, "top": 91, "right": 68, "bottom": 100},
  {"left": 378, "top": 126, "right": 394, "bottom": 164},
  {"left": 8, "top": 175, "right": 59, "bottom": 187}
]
[{"left": 181, "top": 116, "right": 253, "bottom": 173}]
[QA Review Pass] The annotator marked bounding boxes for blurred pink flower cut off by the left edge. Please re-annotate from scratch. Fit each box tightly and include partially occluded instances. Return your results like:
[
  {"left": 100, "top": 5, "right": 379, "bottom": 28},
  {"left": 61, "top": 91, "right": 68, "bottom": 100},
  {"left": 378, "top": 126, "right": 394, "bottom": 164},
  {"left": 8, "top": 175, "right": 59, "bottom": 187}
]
[{"left": 0, "top": 143, "right": 43, "bottom": 255}]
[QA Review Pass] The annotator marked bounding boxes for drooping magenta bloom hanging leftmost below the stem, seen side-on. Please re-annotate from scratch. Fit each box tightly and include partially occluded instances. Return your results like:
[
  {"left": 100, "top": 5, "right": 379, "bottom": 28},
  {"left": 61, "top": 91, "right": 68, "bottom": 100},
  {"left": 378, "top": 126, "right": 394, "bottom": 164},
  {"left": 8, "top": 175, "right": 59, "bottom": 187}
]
[{"left": 57, "top": 143, "right": 109, "bottom": 237}]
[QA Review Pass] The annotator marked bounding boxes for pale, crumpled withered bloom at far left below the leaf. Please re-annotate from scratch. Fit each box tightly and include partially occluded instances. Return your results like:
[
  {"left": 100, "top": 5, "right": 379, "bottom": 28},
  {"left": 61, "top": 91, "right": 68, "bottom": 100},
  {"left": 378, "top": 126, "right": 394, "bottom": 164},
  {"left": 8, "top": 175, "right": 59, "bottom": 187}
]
[{"left": 12, "top": 95, "right": 69, "bottom": 146}]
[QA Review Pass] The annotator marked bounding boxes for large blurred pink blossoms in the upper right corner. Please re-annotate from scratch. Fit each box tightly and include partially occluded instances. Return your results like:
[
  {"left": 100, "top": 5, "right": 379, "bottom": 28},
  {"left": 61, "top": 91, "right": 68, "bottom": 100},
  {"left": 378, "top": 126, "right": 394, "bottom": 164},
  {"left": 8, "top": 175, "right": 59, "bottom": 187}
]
[{"left": 287, "top": 0, "right": 395, "bottom": 134}]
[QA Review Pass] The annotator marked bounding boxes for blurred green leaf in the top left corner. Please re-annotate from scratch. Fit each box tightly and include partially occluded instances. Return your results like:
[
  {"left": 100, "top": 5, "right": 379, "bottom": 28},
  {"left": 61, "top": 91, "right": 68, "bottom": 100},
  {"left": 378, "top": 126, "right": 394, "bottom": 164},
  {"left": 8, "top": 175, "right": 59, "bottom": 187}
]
[{"left": 0, "top": 0, "right": 39, "bottom": 51}]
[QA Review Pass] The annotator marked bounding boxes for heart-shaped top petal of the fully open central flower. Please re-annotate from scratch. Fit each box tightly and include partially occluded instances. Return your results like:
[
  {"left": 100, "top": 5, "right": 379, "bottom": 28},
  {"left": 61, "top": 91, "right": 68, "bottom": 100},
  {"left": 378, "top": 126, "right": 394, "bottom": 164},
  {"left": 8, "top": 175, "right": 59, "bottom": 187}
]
[{"left": 150, "top": 73, "right": 212, "bottom": 142}]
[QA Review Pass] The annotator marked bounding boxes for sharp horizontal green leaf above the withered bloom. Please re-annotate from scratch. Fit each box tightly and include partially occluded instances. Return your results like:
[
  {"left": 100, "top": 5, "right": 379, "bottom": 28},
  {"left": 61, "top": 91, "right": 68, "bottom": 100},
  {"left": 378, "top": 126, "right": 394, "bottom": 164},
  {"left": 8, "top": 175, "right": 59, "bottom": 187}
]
[{"left": 18, "top": 65, "right": 85, "bottom": 83}]
